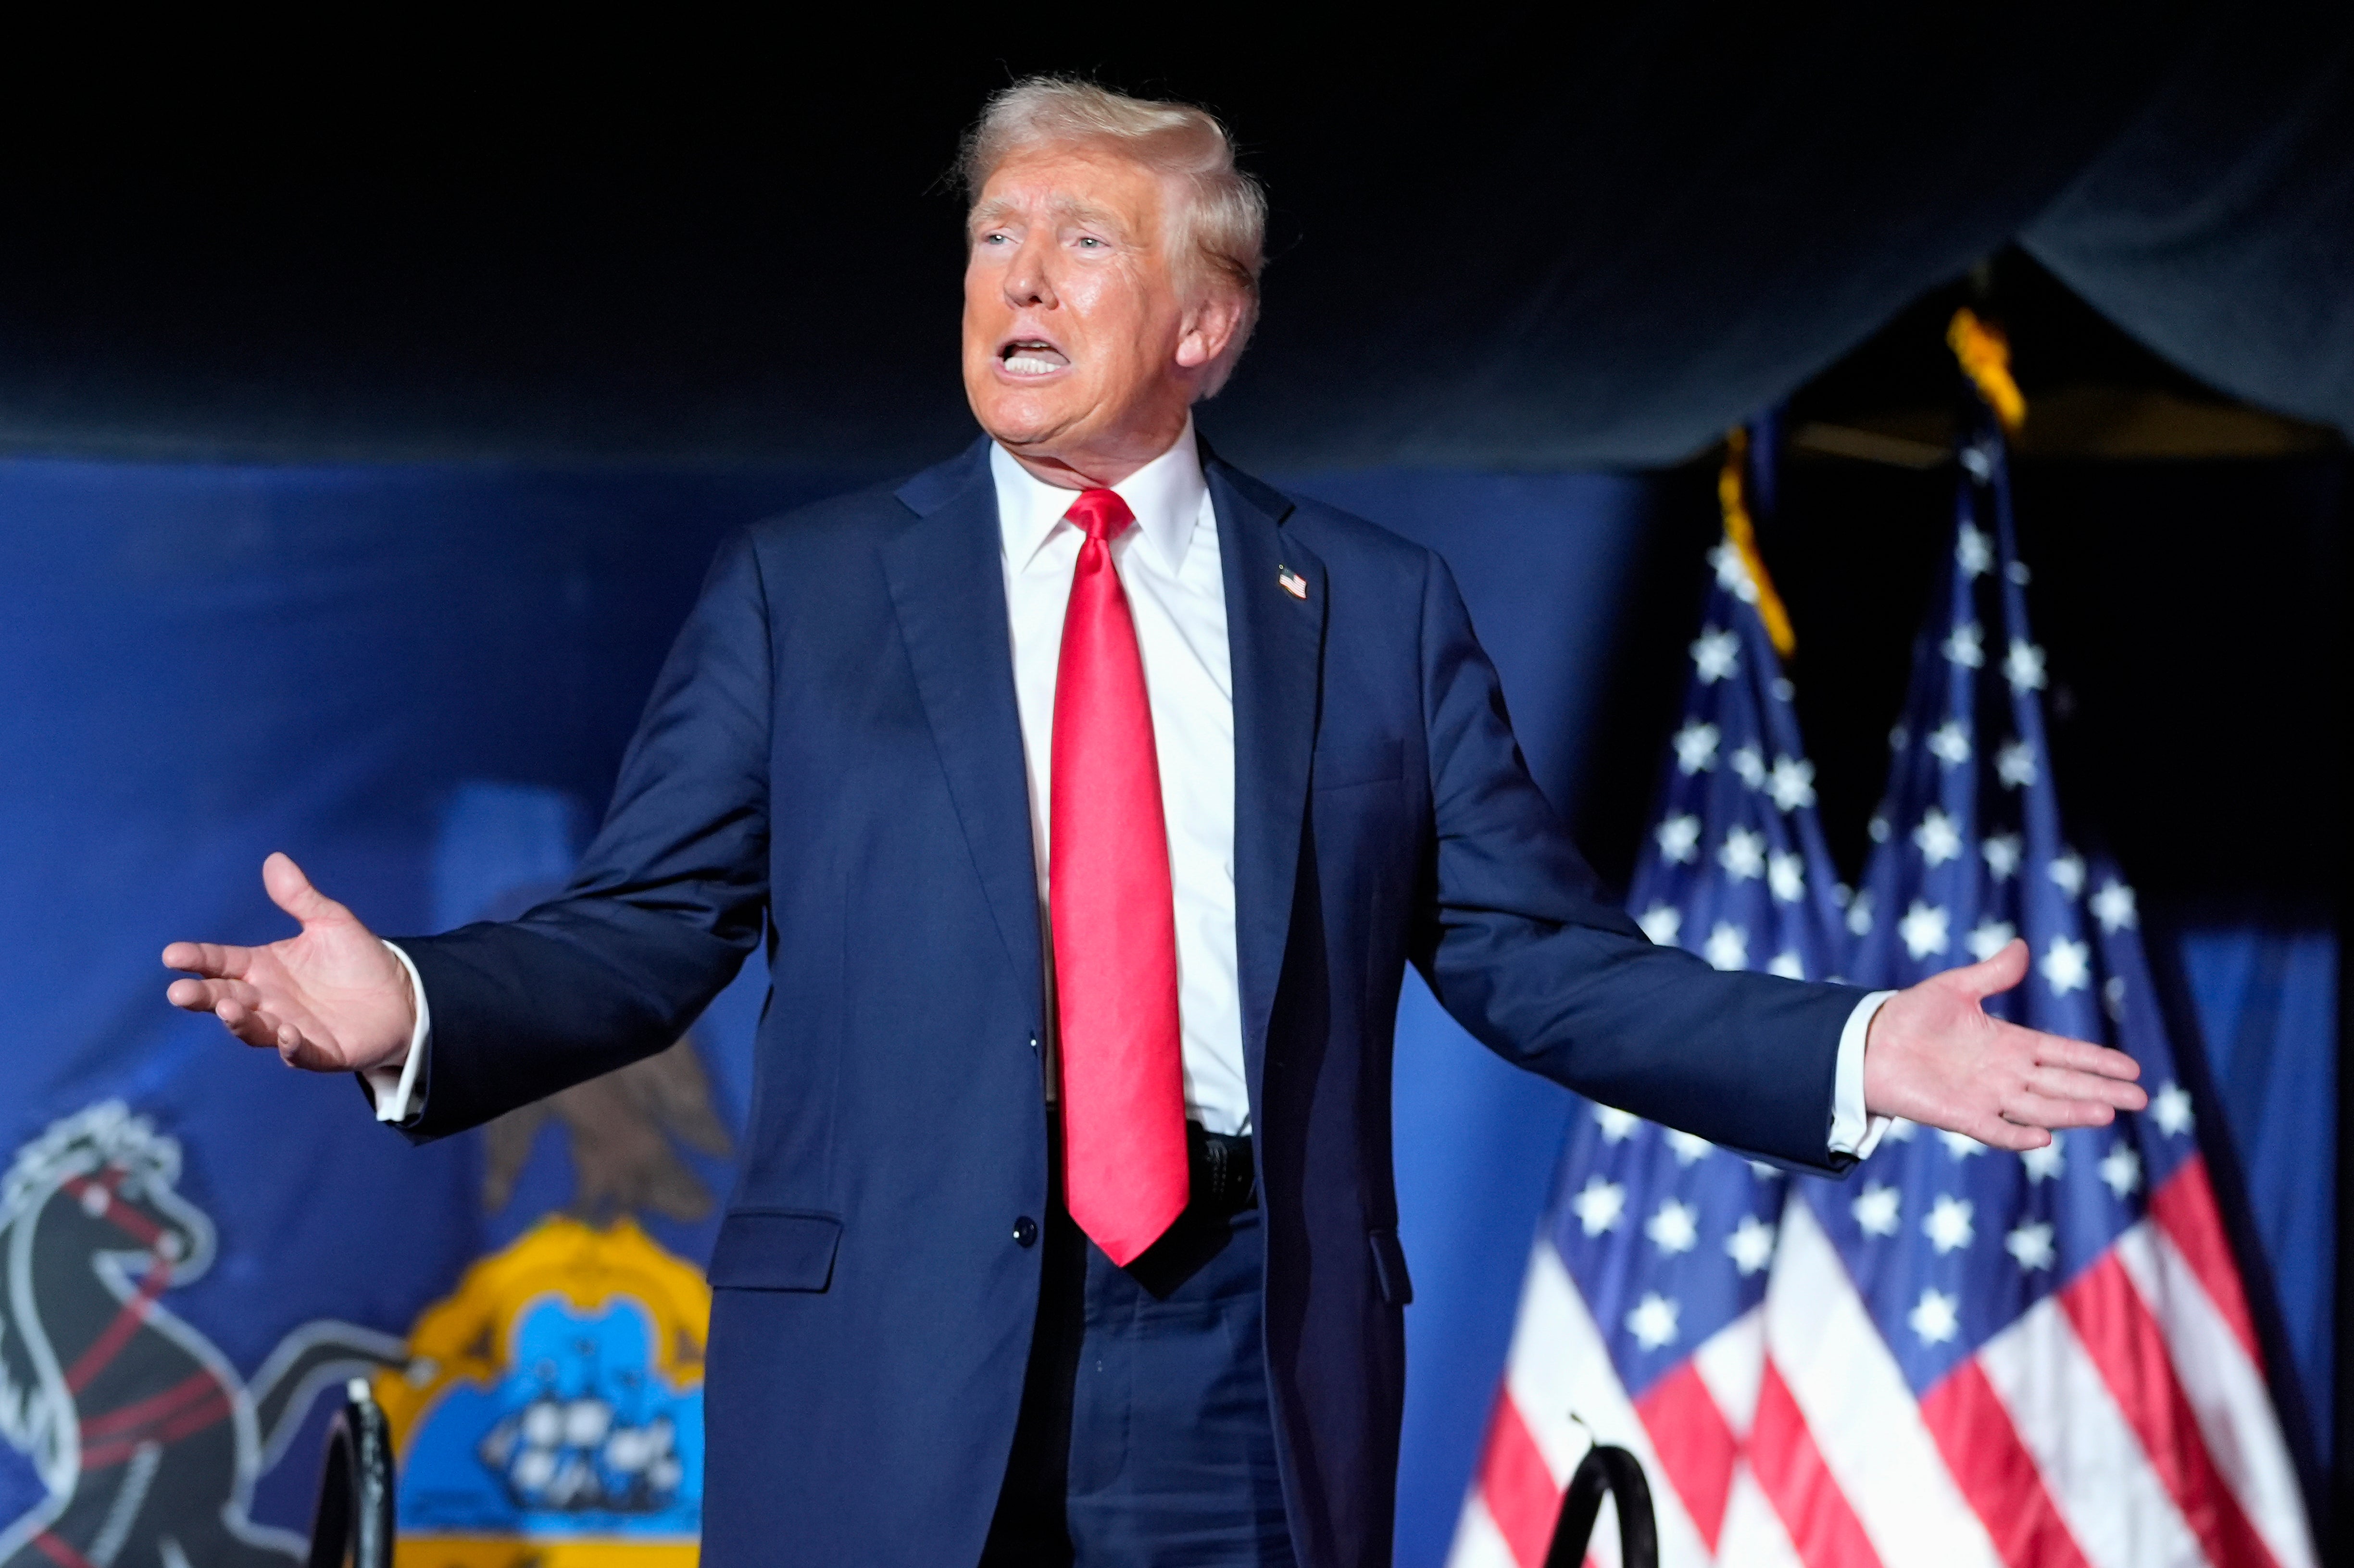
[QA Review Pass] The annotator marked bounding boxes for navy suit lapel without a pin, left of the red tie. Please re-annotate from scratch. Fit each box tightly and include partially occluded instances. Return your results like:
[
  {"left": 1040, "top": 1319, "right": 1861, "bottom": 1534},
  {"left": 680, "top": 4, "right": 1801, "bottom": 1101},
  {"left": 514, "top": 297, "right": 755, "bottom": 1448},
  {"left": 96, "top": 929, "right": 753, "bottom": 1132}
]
[{"left": 883, "top": 440, "right": 1045, "bottom": 1012}]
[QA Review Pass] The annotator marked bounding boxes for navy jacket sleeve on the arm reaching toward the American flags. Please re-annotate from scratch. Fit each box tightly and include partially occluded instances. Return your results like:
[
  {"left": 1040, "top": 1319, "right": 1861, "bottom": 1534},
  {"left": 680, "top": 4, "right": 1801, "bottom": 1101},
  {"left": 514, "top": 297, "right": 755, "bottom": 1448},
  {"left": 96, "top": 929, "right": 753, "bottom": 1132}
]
[{"left": 1413, "top": 544, "right": 1865, "bottom": 1170}]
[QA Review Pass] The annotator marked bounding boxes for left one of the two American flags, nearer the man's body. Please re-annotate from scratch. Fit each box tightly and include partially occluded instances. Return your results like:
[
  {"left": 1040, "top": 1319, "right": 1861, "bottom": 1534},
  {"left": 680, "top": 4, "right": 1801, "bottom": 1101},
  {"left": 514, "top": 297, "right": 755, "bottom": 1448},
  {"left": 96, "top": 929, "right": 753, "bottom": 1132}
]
[{"left": 1450, "top": 436, "right": 1845, "bottom": 1568}]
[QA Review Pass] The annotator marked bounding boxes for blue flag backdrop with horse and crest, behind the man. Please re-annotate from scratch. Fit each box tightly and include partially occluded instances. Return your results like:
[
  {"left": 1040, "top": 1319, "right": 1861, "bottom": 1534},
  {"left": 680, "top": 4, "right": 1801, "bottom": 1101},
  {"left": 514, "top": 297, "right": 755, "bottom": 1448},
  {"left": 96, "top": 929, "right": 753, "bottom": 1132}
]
[{"left": 0, "top": 445, "right": 2335, "bottom": 1568}]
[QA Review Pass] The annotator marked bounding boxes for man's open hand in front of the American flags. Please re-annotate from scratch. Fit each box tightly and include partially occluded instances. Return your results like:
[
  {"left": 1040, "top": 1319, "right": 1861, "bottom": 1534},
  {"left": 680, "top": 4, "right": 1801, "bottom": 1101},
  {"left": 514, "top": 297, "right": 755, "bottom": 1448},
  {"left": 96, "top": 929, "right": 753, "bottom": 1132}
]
[{"left": 1865, "top": 939, "right": 2149, "bottom": 1149}]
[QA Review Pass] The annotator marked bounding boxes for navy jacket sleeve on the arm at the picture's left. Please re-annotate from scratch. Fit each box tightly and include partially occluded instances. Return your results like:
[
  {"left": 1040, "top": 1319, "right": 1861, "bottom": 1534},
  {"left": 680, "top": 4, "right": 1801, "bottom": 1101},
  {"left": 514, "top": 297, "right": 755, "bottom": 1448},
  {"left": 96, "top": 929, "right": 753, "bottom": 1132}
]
[{"left": 400, "top": 535, "right": 775, "bottom": 1140}]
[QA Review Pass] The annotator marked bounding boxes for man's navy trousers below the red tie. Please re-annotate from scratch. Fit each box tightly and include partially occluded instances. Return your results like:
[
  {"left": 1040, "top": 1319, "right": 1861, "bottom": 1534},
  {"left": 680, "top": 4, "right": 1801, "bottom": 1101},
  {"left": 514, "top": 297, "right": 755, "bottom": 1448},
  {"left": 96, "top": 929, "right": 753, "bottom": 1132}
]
[{"left": 982, "top": 1144, "right": 1292, "bottom": 1568}]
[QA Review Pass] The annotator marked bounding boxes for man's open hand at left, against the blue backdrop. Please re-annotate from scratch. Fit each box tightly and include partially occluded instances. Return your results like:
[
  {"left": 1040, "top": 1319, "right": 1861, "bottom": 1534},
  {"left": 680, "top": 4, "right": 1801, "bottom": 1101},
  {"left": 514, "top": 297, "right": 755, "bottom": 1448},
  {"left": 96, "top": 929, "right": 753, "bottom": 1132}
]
[{"left": 163, "top": 855, "right": 417, "bottom": 1073}]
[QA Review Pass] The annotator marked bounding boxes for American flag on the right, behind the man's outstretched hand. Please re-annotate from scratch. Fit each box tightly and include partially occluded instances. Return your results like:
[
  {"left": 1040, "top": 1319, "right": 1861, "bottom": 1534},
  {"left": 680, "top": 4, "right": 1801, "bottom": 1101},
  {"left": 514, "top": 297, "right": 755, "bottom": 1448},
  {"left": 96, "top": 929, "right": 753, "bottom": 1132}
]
[{"left": 1752, "top": 422, "right": 2314, "bottom": 1568}]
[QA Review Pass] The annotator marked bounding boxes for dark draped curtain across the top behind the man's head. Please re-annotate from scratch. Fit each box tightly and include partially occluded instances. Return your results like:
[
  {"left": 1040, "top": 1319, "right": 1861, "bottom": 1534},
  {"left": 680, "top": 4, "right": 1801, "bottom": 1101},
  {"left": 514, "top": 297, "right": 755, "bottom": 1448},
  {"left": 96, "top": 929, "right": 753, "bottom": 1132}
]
[{"left": 0, "top": 0, "right": 2354, "bottom": 469}]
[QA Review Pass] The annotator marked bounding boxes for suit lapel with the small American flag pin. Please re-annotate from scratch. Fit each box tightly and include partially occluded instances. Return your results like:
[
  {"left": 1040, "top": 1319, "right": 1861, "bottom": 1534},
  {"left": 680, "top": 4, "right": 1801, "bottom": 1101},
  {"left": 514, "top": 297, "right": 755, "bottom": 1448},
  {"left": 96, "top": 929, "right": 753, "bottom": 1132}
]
[{"left": 1203, "top": 454, "right": 1325, "bottom": 1125}]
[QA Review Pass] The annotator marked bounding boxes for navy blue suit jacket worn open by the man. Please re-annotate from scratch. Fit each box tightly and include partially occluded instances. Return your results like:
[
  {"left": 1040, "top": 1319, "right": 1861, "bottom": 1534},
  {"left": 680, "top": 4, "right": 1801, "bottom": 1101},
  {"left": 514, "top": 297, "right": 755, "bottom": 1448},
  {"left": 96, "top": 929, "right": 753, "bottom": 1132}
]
[{"left": 390, "top": 443, "right": 1860, "bottom": 1568}]
